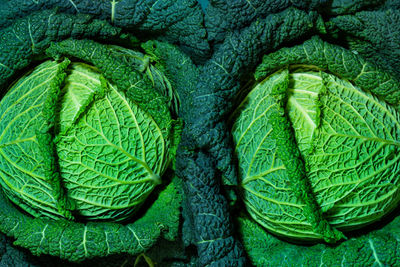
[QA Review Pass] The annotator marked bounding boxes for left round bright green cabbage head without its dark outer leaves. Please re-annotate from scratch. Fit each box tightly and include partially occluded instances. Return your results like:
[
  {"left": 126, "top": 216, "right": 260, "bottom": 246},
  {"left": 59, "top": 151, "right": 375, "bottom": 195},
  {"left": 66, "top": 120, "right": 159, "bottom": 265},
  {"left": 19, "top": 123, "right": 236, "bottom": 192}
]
[{"left": 0, "top": 56, "right": 169, "bottom": 220}]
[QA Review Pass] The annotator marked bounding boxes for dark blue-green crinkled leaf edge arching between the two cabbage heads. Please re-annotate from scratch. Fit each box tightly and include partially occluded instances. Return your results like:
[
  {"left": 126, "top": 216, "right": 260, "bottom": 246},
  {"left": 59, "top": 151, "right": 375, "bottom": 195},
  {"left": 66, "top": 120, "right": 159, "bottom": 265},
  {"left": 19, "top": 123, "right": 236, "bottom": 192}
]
[{"left": 177, "top": 9, "right": 316, "bottom": 266}]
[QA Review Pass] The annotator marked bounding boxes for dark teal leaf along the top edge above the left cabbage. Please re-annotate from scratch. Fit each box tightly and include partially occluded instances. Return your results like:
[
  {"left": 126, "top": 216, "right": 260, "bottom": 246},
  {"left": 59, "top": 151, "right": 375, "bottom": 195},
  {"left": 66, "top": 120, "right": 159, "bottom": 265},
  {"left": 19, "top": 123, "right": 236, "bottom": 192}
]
[{"left": 0, "top": 0, "right": 209, "bottom": 60}]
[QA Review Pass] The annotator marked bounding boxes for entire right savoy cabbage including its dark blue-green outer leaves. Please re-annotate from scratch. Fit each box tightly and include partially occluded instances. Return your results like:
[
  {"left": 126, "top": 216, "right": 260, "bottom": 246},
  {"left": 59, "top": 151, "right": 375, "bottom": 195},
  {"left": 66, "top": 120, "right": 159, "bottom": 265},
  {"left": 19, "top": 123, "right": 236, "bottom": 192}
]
[{"left": 177, "top": 0, "right": 400, "bottom": 266}]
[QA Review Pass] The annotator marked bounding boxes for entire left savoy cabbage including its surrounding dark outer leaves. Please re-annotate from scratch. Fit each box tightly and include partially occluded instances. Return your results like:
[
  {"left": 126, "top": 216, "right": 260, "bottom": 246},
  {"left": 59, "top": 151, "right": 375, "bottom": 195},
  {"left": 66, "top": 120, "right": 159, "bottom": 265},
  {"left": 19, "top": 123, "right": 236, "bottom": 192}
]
[{"left": 0, "top": 1, "right": 203, "bottom": 265}]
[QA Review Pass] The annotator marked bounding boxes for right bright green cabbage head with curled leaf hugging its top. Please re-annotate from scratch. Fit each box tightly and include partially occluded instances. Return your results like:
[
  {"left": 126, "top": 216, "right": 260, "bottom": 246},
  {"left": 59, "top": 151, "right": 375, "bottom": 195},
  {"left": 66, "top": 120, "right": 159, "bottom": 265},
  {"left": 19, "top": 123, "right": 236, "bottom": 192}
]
[{"left": 232, "top": 38, "right": 400, "bottom": 243}]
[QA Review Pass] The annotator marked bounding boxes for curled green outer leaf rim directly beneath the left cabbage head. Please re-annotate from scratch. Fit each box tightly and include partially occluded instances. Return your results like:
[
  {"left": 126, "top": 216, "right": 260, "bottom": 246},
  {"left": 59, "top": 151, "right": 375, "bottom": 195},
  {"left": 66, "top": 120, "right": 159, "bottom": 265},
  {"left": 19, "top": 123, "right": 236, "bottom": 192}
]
[{"left": 0, "top": 177, "right": 181, "bottom": 262}]
